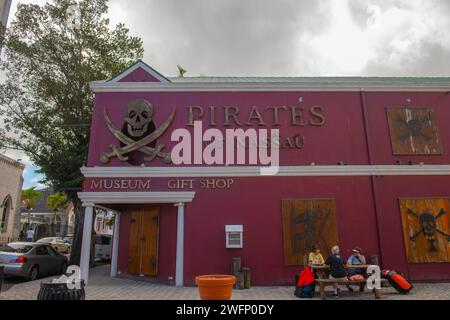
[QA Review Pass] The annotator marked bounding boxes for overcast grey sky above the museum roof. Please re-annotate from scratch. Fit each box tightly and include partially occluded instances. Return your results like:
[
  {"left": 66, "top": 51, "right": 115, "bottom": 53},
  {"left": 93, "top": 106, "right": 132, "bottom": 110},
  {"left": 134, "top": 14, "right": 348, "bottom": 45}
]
[{"left": 2, "top": 0, "right": 450, "bottom": 188}]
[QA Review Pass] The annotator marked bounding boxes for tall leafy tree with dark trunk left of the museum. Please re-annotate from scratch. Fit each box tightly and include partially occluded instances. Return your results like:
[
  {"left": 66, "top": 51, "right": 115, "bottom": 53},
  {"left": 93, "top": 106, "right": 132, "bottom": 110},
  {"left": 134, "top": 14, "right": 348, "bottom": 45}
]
[{"left": 0, "top": 0, "right": 143, "bottom": 264}]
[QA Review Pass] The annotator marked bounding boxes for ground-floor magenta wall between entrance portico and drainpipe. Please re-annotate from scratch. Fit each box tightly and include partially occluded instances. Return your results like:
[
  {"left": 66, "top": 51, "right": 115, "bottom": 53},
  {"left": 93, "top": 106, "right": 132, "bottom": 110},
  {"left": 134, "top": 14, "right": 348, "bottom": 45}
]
[{"left": 185, "top": 177, "right": 378, "bottom": 285}]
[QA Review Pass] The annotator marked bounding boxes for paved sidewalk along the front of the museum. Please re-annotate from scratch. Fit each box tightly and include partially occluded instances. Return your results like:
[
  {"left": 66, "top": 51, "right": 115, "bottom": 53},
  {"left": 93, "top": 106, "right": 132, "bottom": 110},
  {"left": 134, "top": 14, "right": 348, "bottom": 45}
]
[{"left": 0, "top": 265, "right": 450, "bottom": 301}]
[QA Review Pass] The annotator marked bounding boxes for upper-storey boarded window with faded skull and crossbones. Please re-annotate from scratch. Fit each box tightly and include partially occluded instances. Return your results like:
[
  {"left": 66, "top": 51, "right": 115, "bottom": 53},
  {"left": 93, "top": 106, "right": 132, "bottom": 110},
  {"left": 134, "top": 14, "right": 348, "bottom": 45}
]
[{"left": 387, "top": 108, "right": 442, "bottom": 155}]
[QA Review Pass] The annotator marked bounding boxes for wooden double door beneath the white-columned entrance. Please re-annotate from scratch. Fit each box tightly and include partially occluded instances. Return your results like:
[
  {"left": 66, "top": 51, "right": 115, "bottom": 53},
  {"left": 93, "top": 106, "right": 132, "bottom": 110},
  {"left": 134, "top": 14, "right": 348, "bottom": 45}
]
[{"left": 128, "top": 208, "right": 160, "bottom": 277}]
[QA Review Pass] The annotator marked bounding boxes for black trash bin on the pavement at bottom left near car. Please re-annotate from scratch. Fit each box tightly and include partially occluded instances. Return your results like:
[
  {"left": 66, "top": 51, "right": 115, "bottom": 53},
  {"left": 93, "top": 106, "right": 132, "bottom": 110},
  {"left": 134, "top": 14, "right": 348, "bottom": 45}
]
[{"left": 38, "top": 280, "right": 86, "bottom": 301}]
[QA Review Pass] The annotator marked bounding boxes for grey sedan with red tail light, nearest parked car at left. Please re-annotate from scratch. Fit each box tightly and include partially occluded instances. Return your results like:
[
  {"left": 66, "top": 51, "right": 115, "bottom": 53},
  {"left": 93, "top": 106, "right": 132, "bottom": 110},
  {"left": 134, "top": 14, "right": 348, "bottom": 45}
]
[{"left": 0, "top": 242, "right": 68, "bottom": 280}]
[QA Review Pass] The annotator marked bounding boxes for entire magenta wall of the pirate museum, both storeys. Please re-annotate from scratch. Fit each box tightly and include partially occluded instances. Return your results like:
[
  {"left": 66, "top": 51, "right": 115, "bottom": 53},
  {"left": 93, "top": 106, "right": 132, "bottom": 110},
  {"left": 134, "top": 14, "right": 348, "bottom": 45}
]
[{"left": 84, "top": 88, "right": 450, "bottom": 285}]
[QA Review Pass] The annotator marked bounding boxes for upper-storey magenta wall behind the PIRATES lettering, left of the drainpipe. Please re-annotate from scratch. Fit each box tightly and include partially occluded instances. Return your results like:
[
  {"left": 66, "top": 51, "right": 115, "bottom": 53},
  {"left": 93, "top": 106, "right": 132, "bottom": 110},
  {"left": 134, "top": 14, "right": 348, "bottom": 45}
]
[{"left": 88, "top": 93, "right": 368, "bottom": 167}]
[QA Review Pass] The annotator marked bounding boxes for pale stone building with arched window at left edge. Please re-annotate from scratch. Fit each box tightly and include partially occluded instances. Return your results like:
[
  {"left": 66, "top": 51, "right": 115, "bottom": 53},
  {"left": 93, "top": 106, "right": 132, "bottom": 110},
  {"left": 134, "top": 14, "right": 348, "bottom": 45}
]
[{"left": 0, "top": 154, "right": 25, "bottom": 244}]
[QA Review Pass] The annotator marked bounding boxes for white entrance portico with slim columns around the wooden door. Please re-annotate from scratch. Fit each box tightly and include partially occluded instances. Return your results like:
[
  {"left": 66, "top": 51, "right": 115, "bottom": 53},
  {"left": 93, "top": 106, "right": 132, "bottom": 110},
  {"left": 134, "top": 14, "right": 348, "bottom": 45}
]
[{"left": 78, "top": 192, "right": 195, "bottom": 287}]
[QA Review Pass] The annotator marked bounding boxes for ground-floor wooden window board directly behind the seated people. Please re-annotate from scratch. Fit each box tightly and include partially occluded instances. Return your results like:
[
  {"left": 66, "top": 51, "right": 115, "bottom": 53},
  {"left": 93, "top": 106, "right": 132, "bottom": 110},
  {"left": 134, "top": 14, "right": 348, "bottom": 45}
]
[{"left": 282, "top": 200, "right": 339, "bottom": 266}]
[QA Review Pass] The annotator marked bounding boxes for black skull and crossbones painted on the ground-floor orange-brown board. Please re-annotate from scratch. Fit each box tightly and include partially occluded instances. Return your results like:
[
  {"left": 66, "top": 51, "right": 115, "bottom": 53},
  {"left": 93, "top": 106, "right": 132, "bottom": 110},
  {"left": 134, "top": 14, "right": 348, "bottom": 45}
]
[{"left": 408, "top": 209, "right": 450, "bottom": 252}]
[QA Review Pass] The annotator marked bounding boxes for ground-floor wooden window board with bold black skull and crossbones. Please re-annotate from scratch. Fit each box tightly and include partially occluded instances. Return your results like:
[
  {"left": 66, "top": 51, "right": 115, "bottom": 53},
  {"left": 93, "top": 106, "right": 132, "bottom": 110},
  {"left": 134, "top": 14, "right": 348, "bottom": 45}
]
[{"left": 400, "top": 198, "right": 450, "bottom": 263}]
